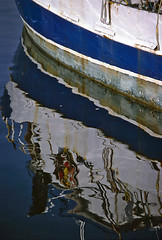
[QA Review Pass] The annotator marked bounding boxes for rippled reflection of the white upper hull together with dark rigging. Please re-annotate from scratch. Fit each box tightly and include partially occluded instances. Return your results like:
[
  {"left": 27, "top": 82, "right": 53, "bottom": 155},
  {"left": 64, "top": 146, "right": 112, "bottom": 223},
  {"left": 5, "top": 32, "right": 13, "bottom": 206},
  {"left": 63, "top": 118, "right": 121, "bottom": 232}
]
[{"left": 2, "top": 71, "right": 161, "bottom": 239}]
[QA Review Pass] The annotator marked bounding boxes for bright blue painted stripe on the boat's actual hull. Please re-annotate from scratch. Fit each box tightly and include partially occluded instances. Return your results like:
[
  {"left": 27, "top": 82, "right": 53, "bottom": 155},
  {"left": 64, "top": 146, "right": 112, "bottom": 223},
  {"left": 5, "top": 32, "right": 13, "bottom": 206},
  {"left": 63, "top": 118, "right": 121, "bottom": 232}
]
[{"left": 16, "top": 0, "right": 162, "bottom": 80}]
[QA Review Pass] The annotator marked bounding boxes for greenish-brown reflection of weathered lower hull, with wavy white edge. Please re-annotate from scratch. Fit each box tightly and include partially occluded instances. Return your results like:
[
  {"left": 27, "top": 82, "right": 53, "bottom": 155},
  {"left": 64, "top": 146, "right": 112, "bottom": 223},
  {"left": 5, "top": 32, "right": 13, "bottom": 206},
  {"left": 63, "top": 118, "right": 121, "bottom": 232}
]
[{"left": 22, "top": 26, "right": 162, "bottom": 138}]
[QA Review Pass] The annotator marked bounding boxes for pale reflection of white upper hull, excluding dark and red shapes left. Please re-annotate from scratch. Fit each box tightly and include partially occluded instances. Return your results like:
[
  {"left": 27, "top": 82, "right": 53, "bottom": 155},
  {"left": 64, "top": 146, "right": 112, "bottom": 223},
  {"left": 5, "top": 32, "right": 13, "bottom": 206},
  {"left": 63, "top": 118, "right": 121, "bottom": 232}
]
[{"left": 6, "top": 81, "right": 162, "bottom": 229}]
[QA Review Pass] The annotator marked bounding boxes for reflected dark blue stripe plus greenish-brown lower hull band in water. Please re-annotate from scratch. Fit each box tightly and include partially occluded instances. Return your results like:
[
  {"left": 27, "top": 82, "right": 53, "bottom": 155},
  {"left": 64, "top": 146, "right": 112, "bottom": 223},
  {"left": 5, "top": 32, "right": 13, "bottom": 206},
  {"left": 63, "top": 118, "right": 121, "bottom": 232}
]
[{"left": 7, "top": 30, "right": 162, "bottom": 161}]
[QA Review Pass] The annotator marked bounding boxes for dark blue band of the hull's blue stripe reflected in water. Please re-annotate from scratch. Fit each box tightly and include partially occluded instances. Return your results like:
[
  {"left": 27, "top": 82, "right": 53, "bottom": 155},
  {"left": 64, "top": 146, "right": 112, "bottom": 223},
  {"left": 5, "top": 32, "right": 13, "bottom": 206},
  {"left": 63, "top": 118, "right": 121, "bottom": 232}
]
[{"left": 7, "top": 41, "right": 162, "bottom": 160}]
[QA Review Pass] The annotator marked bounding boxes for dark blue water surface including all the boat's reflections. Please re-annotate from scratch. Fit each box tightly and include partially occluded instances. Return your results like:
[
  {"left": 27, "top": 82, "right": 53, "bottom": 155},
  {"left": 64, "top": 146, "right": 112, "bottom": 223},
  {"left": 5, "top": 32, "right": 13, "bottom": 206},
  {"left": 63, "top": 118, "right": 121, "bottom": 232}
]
[{"left": 0, "top": 0, "right": 162, "bottom": 240}]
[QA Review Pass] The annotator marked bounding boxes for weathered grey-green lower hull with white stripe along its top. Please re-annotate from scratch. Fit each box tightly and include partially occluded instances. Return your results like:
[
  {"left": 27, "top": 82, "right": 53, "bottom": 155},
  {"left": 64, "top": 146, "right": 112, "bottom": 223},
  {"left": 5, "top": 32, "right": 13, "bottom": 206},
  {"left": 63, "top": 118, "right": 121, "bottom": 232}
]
[{"left": 24, "top": 22, "right": 162, "bottom": 108}]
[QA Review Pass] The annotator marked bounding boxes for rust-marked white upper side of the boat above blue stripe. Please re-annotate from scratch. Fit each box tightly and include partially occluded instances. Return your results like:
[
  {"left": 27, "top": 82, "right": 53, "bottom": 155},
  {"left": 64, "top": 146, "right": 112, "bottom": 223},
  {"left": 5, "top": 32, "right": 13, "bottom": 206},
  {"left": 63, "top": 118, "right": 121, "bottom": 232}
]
[{"left": 33, "top": 0, "right": 162, "bottom": 54}]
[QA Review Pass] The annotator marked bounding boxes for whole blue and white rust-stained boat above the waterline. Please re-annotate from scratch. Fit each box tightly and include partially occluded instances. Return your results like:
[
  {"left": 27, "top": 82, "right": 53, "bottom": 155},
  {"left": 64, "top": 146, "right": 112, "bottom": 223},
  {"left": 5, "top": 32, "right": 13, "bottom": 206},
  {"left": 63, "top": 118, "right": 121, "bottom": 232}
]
[{"left": 16, "top": 0, "right": 162, "bottom": 108}]
